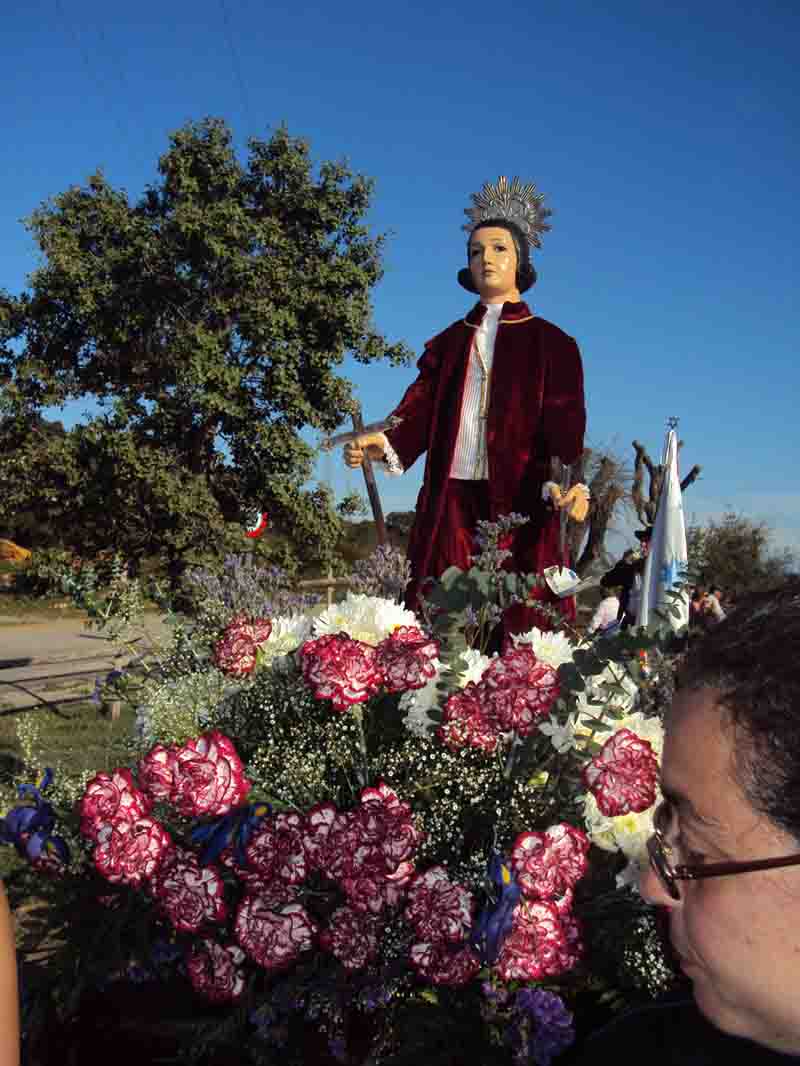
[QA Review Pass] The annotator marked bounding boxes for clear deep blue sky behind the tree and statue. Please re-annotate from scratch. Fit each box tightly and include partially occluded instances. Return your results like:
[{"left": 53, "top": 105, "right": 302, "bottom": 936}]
[{"left": 0, "top": 0, "right": 800, "bottom": 550}]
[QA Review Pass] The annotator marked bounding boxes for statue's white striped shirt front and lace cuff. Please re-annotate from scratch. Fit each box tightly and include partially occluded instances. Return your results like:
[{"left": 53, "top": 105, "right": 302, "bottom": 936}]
[{"left": 383, "top": 304, "right": 502, "bottom": 481}]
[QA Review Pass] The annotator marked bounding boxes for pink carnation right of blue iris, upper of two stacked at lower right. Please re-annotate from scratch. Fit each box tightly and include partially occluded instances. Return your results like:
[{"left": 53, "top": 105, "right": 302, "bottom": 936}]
[{"left": 511, "top": 822, "right": 589, "bottom": 900}]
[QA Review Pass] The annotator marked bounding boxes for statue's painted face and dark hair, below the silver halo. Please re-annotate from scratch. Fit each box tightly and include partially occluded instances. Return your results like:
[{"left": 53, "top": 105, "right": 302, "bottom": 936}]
[{"left": 459, "top": 219, "right": 537, "bottom": 303}]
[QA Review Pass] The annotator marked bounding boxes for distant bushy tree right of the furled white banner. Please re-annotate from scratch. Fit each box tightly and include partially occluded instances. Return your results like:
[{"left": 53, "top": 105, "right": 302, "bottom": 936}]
[{"left": 686, "top": 511, "right": 797, "bottom": 598}]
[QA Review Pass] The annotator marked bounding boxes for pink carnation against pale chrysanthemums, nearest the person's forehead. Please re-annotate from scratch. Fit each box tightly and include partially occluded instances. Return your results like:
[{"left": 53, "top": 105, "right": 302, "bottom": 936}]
[{"left": 583, "top": 729, "right": 658, "bottom": 818}]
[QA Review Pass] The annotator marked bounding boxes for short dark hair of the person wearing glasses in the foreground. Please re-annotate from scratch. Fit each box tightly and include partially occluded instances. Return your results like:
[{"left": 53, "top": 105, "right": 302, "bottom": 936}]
[{"left": 681, "top": 578, "right": 800, "bottom": 841}]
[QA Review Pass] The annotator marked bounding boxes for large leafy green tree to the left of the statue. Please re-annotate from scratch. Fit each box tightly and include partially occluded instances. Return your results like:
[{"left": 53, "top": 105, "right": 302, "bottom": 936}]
[{"left": 0, "top": 119, "right": 409, "bottom": 563}]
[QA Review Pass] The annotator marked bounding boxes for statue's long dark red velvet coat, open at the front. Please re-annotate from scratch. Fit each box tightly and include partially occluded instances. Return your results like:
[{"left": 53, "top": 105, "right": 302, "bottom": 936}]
[{"left": 386, "top": 303, "right": 586, "bottom": 628}]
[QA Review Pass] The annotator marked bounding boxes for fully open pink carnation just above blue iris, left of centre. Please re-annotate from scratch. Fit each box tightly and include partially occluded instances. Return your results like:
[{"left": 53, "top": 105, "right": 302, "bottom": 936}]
[{"left": 171, "top": 731, "right": 251, "bottom": 818}]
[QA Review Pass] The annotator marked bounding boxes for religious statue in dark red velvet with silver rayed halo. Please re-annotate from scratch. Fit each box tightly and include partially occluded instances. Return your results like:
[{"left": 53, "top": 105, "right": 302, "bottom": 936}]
[{"left": 345, "top": 170, "right": 588, "bottom": 632}]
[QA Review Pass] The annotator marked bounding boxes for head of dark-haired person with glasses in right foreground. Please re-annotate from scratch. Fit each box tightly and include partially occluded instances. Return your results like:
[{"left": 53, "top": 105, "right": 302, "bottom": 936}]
[{"left": 641, "top": 579, "right": 800, "bottom": 1053}]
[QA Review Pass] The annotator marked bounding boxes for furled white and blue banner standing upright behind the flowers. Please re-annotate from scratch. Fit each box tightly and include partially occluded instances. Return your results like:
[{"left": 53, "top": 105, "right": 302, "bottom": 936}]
[{"left": 637, "top": 430, "right": 689, "bottom": 632}]
